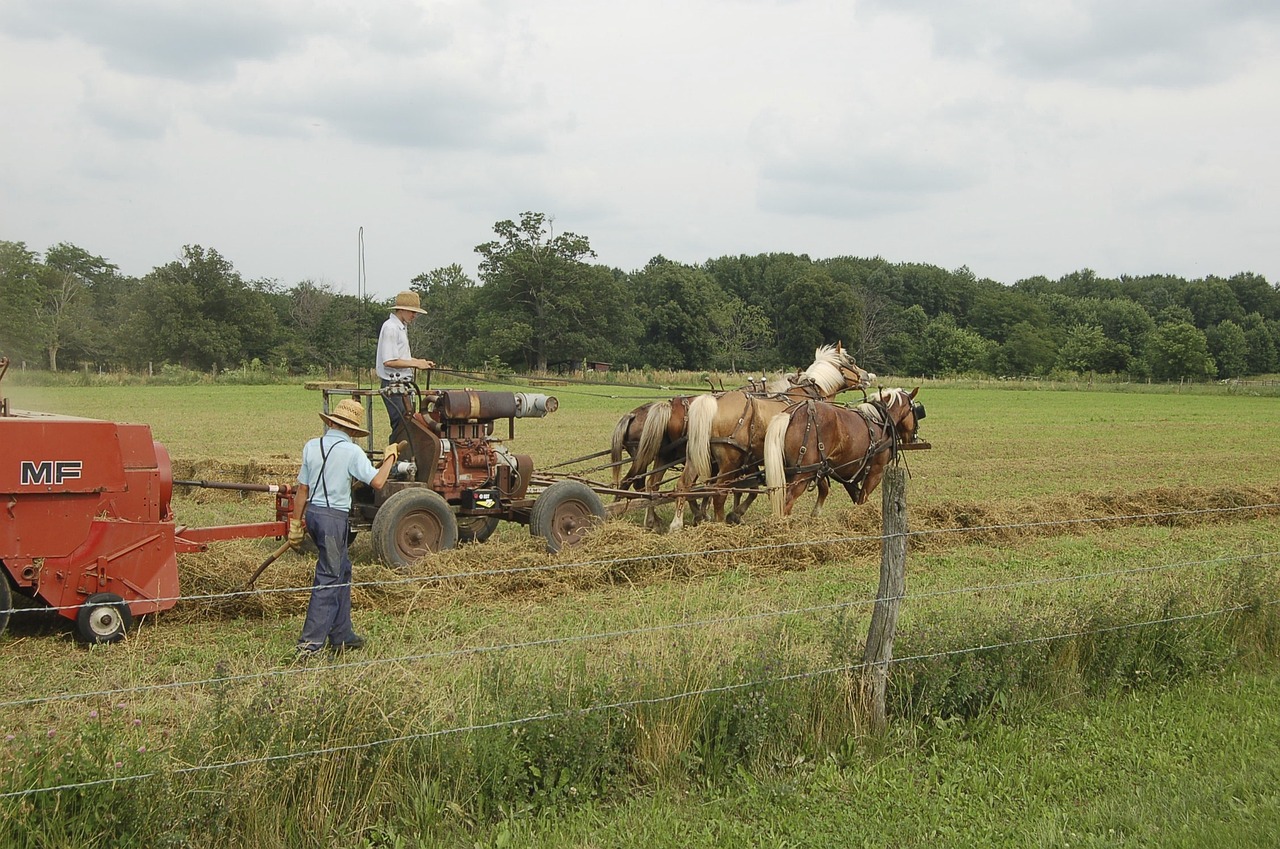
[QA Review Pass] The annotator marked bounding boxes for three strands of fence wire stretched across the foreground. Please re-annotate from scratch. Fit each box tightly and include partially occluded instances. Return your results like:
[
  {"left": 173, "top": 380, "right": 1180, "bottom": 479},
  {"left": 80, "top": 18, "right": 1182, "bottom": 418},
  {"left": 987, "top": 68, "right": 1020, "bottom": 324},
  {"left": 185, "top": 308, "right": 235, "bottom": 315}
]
[{"left": 0, "top": 503, "right": 1280, "bottom": 799}]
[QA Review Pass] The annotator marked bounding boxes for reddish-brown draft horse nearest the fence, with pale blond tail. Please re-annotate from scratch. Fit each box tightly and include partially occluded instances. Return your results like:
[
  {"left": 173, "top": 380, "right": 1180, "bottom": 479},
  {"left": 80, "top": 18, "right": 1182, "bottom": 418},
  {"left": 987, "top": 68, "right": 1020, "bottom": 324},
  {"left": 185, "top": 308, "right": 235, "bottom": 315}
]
[{"left": 764, "top": 387, "right": 924, "bottom": 516}]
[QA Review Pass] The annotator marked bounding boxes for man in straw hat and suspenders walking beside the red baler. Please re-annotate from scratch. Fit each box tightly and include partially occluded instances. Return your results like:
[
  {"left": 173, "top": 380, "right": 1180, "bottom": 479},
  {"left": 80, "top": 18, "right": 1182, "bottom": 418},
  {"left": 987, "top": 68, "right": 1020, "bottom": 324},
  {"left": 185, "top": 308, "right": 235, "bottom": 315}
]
[{"left": 289, "top": 398, "right": 399, "bottom": 657}]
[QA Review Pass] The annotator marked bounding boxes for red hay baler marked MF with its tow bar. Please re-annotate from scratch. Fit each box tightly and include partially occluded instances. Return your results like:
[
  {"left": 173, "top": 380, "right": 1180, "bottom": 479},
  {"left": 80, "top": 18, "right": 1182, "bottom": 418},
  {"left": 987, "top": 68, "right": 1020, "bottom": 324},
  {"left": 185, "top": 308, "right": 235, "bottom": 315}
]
[{"left": 0, "top": 359, "right": 293, "bottom": 643}]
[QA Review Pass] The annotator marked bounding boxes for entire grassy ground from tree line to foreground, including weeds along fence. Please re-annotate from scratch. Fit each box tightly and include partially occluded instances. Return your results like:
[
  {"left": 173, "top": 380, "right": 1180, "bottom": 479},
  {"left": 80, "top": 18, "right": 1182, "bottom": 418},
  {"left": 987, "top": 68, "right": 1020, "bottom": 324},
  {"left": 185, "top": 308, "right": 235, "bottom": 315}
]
[{"left": 0, "top": 385, "right": 1280, "bottom": 846}]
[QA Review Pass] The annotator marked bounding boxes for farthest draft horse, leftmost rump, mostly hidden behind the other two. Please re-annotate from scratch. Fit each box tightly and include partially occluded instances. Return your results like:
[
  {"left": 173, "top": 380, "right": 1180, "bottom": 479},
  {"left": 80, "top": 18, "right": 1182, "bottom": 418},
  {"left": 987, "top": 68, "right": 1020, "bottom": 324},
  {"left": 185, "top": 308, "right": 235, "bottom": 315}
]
[{"left": 609, "top": 375, "right": 791, "bottom": 529}]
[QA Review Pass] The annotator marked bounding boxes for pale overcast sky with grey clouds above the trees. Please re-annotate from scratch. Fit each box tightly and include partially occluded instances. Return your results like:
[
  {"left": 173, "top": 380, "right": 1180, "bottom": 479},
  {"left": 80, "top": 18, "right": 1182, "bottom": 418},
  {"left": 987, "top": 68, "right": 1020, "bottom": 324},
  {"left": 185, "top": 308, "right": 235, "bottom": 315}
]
[{"left": 0, "top": 0, "right": 1280, "bottom": 297}]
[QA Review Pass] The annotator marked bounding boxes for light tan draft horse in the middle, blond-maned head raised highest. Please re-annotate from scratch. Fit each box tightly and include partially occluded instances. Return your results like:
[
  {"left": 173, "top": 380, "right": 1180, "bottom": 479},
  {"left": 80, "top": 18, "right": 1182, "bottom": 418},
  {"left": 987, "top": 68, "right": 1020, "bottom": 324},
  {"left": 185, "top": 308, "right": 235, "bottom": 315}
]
[{"left": 671, "top": 342, "right": 876, "bottom": 530}]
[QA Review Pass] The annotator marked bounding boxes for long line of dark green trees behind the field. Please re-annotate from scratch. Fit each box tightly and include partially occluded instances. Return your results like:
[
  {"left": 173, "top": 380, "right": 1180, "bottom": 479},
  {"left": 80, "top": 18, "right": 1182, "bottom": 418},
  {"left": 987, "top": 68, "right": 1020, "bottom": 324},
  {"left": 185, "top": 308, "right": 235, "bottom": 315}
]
[{"left": 0, "top": 213, "right": 1280, "bottom": 380}]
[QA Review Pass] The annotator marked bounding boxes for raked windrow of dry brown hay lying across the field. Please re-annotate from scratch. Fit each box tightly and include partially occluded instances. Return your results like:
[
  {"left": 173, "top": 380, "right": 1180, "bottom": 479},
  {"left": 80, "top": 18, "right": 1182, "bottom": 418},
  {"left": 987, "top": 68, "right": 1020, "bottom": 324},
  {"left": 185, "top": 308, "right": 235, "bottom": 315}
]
[{"left": 170, "top": 485, "right": 1280, "bottom": 619}]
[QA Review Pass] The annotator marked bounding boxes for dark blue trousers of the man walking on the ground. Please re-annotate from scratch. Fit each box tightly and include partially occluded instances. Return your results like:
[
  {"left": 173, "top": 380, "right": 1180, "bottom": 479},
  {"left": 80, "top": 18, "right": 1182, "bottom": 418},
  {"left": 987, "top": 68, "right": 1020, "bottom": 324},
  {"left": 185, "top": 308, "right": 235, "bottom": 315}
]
[{"left": 298, "top": 505, "right": 356, "bottom": 652}]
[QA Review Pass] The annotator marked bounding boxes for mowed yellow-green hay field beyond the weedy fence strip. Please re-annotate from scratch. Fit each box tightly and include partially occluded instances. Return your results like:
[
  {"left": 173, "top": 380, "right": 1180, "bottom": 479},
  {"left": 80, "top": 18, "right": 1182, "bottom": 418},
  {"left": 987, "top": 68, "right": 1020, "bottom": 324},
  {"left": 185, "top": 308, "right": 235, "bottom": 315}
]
[{"left": 0, "top": 384, "right": 1280, "bottom": 845}]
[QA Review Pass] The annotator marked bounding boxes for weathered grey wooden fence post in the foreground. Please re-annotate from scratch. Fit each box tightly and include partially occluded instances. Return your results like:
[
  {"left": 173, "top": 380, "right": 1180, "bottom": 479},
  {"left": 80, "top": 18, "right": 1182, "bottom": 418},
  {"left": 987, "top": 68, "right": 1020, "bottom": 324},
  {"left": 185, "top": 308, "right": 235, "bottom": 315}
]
[{"left": 863, "top": 462, "right": 906, "bottom": 734}]
